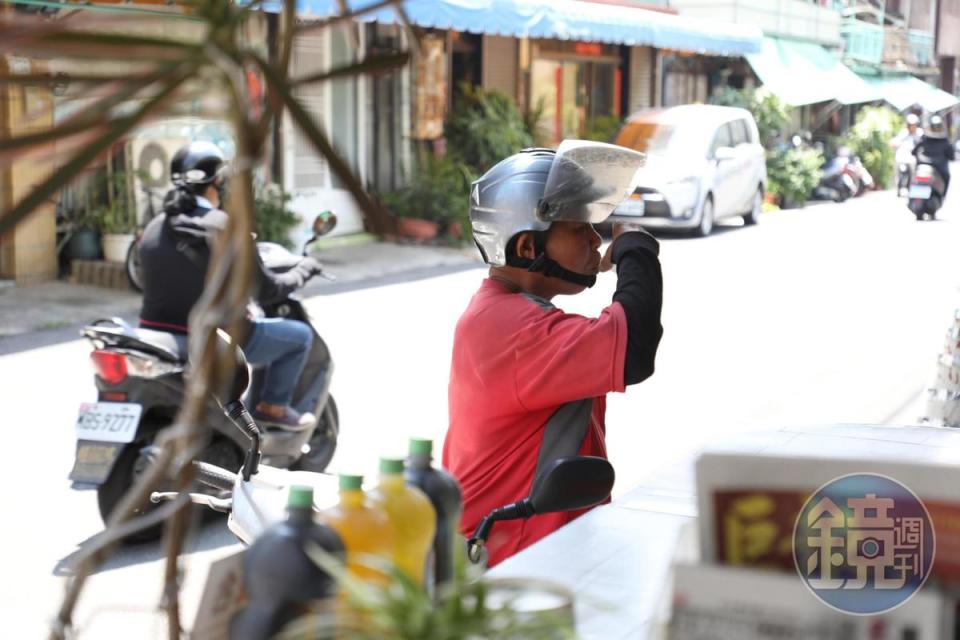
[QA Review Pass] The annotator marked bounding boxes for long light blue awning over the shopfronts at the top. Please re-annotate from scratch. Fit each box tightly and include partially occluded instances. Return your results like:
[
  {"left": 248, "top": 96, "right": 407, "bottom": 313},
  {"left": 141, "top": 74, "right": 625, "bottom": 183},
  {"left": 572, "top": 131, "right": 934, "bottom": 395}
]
[{"left": 288, "top": 0, "right": 762, "bottom": 55}]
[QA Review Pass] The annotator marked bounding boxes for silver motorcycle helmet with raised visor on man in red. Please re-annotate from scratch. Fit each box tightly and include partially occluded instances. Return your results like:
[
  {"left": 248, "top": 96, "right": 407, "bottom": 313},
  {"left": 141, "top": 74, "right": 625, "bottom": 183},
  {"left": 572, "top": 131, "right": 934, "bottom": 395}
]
[{"left": 470, "top": 140, "right": 644, "bottom": 286}]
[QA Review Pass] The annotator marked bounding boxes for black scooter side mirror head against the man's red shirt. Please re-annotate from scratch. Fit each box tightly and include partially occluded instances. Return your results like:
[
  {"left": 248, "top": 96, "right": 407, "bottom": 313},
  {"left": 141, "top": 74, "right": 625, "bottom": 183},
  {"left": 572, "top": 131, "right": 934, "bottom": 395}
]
[{"left": 530, "top": 456, "right": 614, "bottom": 513}]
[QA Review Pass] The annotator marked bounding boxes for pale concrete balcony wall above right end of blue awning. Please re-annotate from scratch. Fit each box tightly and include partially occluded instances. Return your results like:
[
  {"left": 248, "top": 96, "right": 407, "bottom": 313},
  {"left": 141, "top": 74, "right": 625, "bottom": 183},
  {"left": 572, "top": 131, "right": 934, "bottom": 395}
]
[{"left": 670, "top": 0, "right": 840, "bottom": 45}]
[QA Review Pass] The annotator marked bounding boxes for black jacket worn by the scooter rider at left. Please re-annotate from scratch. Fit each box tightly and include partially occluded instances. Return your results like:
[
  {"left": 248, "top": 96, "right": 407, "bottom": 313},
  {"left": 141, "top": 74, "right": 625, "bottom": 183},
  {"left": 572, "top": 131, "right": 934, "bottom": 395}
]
[{"left": 140, "top": 192, "right": 314, "bottom": 333}]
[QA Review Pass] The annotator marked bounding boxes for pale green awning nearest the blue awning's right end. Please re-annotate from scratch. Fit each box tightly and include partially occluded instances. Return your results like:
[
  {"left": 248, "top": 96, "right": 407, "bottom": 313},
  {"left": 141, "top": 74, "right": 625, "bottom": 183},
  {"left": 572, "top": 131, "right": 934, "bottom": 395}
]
[{"left": 746, "top": 36, "right": 882, "bottom": 107}]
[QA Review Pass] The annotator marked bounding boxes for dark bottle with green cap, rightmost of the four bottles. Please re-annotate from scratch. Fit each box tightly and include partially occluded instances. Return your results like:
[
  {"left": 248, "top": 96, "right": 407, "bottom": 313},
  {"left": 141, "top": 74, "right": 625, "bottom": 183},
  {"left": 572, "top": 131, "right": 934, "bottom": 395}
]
[{"left": 405, "top": 438, "right": 464, "bottom": 590}]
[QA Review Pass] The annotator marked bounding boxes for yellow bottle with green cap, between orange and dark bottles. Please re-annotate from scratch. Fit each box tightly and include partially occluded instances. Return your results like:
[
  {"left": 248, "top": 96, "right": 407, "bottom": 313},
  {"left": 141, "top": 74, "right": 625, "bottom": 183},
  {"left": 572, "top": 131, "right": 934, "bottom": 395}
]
[{"left": 370, "top": 458, "right": 437, "bottom": 587}]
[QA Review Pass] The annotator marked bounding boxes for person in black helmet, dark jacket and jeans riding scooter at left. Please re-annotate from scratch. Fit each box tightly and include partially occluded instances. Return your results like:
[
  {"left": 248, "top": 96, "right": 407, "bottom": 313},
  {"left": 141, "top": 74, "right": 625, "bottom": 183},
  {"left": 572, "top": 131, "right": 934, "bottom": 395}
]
[{"left": 140, "top": 142, "right": 320, "bottom": 430}]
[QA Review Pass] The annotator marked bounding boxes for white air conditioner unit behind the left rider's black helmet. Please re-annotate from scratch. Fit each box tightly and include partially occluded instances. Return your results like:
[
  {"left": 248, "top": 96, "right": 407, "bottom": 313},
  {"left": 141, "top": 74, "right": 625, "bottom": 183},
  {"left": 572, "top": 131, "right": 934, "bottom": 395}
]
[{"left": 126, "top": 137, "right": 190, "bottom": 224}]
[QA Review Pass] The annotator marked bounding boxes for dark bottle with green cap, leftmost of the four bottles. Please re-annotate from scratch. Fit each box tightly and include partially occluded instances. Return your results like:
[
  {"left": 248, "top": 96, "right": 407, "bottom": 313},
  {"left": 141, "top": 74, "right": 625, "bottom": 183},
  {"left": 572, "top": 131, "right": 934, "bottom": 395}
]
[{"left": 230, "top": 486, "right": 344, "bottom": 640}]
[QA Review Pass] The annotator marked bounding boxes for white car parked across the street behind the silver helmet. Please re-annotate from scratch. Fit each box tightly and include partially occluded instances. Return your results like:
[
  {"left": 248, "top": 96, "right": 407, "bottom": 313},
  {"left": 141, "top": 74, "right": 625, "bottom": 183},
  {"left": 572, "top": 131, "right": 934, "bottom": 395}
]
[{"left": 613, "top": 104, "right": 767, "bottom": 236}]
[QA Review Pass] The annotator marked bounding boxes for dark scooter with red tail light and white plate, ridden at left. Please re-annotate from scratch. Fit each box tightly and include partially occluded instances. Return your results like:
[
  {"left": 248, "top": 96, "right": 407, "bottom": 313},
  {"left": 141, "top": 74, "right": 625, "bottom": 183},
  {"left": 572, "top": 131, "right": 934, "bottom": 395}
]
[{"left": 70, "top": 214, "right": 339, "bottom": 539}]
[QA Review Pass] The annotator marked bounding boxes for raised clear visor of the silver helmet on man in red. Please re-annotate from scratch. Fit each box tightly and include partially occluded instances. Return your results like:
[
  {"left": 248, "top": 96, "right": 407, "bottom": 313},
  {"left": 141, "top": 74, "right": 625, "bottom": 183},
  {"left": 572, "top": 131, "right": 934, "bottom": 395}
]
[{"left": 537, "top": 140, "right": 645, "bottom": 224}]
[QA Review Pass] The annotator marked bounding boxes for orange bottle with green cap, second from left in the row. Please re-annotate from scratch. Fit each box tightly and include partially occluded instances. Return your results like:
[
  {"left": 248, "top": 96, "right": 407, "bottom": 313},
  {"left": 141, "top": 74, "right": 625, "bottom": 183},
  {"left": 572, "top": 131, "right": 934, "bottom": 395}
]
[{"left": 320, "top": 474, "right": 396, "bottom": 582}]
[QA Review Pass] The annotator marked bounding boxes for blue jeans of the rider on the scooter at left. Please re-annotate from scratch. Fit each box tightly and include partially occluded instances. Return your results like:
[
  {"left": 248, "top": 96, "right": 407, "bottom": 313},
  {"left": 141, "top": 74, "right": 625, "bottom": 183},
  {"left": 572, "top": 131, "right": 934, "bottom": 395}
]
[{"left": 243, "top": 318, "right": 313, "bottom": 405}]
